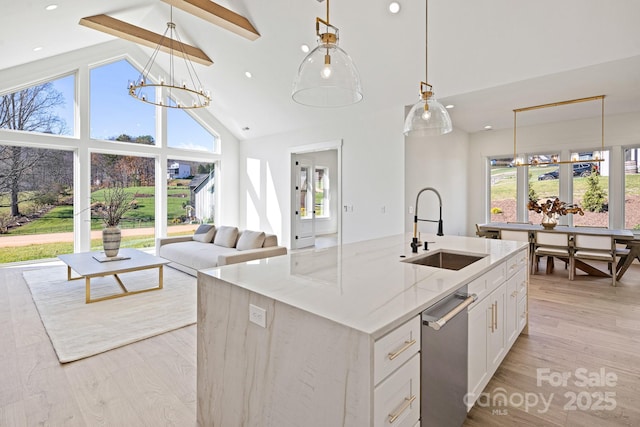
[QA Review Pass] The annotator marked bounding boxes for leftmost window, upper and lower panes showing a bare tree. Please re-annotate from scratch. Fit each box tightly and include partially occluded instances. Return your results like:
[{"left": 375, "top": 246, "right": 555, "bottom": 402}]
[{"left": 0, "top": 73, "right": 76, "bottom": 263}]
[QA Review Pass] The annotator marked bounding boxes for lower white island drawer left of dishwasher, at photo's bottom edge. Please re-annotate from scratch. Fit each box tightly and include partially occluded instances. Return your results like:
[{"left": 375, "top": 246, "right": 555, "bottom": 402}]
[{"left": 373, "top": 354, "right": 420, "bottom": 427}]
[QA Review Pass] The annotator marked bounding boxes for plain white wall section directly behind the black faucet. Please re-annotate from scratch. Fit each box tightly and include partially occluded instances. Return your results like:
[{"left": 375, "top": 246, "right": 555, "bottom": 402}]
[{"left": 403, "top": 128, "right": 469, "bottom": 236}]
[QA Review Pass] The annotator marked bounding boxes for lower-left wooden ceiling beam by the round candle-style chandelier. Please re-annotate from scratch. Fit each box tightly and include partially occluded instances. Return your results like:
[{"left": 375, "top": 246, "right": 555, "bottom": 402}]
[{"left": 80, "top": 15, "right": 213, "bottom": 65}]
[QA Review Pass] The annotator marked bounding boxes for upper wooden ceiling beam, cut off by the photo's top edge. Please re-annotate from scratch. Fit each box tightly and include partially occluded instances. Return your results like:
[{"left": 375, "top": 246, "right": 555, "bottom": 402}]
[{"left": 162, "top": 0, "right": 260, "bottom": 41}]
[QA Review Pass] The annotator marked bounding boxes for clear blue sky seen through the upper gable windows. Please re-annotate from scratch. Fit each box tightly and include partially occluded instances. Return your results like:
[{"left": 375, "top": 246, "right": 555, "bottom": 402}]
[{"left": 52, "top": 60, "right": 215, "bottom": 151}]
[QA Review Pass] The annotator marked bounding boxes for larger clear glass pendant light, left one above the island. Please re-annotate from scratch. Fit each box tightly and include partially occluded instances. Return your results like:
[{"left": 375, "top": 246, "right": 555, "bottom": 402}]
[{"left": 291, "top": 0, "right": 362, "bottom": 107}]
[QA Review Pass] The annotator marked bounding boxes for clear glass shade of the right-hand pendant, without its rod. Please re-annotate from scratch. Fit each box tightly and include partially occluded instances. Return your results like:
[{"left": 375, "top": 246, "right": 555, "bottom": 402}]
[{"left": 404, "top": 93, "right": 453, "bottom": 136}]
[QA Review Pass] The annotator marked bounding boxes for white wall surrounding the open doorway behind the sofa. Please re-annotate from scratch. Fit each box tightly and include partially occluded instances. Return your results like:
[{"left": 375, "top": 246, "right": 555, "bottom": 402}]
[{"left": 239, "top": 106, "right": 404, "bottom": 244}]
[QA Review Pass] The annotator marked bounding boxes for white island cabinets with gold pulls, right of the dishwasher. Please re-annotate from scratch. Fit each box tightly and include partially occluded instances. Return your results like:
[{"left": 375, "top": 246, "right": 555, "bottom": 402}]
[{"left": 467, "top": 248, "right": 528, "bottom": 409}]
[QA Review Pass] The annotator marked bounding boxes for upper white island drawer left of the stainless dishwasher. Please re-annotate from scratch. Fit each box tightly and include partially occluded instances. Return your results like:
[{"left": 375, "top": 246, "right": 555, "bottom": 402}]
[{"left": 373, "top": 316, "right": 420, "bottom": 384}]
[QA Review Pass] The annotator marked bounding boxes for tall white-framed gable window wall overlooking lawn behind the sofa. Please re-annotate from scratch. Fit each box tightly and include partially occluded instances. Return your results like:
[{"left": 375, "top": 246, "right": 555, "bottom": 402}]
[{"left": 0, "top": 51, "right": 220, "bottom": 263}]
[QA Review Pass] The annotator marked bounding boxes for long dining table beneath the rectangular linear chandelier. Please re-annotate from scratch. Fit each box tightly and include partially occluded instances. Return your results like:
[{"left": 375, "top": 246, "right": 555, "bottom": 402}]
[{"left": 478, "top": 222, "right": 640, "bottom": 280}]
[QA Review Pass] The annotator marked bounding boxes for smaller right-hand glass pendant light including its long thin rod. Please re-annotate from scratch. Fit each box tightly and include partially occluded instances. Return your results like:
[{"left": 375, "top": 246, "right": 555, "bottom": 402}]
[{"left": 404, "top": 0, "right": 453, "bottom": 136}]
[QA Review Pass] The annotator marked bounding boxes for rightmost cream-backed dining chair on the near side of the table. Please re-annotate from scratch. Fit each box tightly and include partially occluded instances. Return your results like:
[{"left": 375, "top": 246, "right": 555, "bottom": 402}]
[{"left": 569, "top": 233, "right": 617, "bottom": 286}]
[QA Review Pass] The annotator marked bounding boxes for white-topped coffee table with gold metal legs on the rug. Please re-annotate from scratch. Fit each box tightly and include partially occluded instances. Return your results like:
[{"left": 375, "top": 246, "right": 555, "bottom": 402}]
[{"left": 58, "top": 248, "right": 169, "bottom": 304}]
